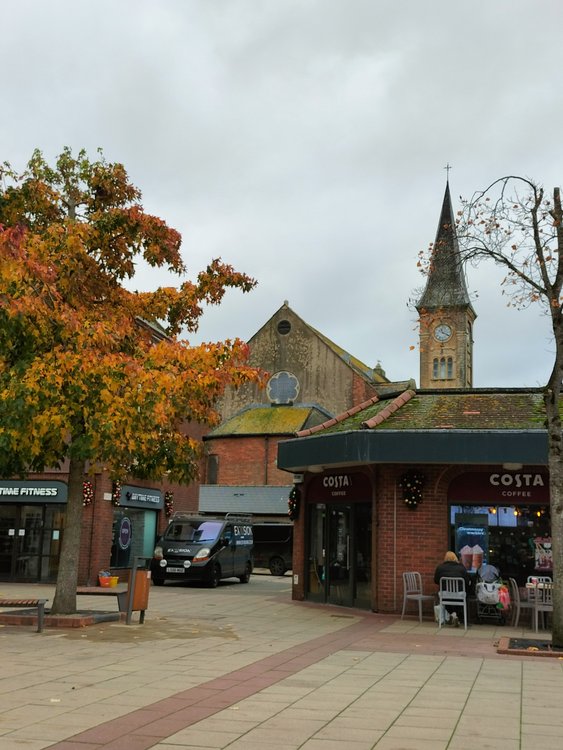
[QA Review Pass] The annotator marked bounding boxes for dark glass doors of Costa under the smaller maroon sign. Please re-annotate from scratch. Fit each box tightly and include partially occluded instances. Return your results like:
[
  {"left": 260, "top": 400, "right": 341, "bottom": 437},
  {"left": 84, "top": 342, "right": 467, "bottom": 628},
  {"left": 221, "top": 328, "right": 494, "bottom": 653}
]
[{"left": 308, "top": 503, "right": 371, "bottom": 609}]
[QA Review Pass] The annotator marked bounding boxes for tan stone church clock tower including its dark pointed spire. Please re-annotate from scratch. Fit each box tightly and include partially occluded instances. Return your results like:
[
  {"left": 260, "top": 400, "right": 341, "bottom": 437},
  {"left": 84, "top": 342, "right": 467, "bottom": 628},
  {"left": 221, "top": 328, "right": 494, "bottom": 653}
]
[{"left": 416, "top": 183, "right": 477, "bottom": 388}]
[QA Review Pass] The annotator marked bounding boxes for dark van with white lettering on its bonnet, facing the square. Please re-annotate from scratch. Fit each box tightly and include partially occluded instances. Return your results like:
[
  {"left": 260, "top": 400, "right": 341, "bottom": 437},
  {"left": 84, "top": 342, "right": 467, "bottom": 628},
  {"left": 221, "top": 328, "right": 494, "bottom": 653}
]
[{"left": 151, "top": 513, "right": 253, "bottom": 588}]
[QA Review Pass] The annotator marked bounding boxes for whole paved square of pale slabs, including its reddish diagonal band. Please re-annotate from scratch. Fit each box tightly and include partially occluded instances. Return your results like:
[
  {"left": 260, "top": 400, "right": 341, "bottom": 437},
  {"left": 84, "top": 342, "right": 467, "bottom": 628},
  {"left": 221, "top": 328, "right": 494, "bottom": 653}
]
[{"left": 0, "top": 575, "right": 563, "bottom": 750}]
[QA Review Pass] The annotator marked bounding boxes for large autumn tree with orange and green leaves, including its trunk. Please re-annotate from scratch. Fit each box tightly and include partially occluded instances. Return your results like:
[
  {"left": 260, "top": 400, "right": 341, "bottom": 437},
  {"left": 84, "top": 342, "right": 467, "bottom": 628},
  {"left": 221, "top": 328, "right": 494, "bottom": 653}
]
[{"left": 0, "top": 148, "right": 260, "bottom": 614}]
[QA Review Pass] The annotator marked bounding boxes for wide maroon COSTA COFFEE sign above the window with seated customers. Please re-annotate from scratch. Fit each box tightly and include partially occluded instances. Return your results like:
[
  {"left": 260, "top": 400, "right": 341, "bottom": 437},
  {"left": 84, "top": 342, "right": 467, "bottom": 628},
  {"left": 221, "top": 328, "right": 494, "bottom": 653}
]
[{"left": 448, "top": 471, "right": 549, "bottom": 504}]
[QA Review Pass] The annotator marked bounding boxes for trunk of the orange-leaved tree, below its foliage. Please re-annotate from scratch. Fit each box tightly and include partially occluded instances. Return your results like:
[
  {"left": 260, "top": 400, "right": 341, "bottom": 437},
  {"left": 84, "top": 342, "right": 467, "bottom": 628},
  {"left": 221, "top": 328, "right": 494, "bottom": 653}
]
[{"left": 51, "top": 459, "right": 85, "bottom": 615}]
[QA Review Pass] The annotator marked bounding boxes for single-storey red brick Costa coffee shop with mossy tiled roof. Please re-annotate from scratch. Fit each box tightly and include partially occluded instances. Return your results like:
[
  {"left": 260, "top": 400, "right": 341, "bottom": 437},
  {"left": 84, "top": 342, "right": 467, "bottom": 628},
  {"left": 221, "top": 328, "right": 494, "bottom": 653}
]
[{"left": 278, "top": 384, "right": 551, "bottom": 612}]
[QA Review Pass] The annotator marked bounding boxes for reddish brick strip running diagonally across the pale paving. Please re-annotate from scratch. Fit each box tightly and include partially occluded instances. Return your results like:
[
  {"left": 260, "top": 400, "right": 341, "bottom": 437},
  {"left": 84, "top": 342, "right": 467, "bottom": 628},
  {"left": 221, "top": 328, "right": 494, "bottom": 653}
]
[{"left": 49, "top": 618, "right": 384, "bottom": 750}]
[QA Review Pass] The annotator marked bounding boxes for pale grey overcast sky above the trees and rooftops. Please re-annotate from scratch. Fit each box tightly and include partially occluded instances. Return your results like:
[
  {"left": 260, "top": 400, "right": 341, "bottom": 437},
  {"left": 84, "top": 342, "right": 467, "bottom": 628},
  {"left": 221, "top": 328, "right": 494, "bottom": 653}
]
[{"left": 0, "top": 0, "right": 563, "bottom": 394}]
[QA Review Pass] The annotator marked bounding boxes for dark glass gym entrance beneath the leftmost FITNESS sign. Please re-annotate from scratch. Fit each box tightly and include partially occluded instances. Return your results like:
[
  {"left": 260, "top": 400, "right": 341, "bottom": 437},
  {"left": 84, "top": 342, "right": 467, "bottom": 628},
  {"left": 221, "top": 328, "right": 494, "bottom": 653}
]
[{"left": 0, "top": 504, "right": 65, "bottom": 583}]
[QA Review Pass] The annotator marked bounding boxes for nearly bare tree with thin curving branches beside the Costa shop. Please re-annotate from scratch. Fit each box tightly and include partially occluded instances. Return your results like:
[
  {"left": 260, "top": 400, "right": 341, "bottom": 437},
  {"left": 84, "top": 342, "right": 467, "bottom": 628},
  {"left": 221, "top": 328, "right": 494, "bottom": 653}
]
[{"left": 430, "top": 176, "right": 563, "bottom": 647}]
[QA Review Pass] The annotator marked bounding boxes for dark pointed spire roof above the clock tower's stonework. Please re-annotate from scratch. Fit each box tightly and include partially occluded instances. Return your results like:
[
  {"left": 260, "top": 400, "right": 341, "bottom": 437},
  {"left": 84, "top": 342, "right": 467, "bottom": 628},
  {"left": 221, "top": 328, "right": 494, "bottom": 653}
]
[{"left": 416, "top": 181, "right": 471, "bottom": 312}]
